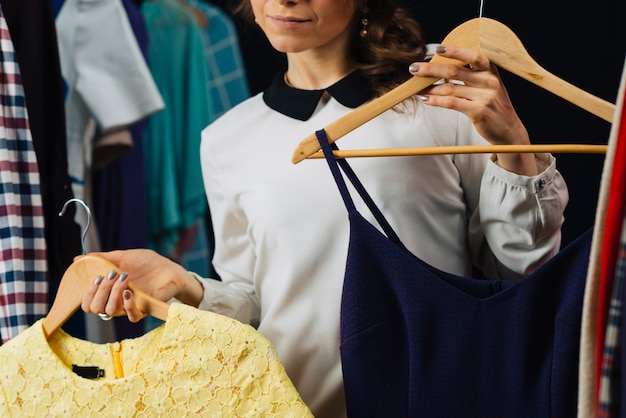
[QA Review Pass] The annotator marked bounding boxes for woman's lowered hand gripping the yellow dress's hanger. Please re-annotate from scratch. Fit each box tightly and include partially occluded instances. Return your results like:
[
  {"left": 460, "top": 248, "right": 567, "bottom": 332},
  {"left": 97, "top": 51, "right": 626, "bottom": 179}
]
[{"left": 81, "top": 249, "right": 204, "bottom": 322}]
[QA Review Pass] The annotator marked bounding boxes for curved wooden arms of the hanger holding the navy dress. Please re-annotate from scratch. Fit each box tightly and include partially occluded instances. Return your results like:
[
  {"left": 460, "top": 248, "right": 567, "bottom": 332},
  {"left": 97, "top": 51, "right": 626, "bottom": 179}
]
[{"left": 291, "top": 17, "right": 615, "bottom": 164}]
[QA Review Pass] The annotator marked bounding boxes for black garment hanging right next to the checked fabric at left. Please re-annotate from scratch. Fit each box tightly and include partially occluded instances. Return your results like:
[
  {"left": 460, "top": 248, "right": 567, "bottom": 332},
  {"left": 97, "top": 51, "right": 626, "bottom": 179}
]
[{"left": 0, "top": 0, "right": 81, "bottom": 290}]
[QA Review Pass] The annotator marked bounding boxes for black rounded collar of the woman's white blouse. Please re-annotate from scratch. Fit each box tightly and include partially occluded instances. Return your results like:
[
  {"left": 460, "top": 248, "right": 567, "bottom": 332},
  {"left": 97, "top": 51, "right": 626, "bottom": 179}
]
[{"left": 263, "top": 71, "right": 374, "bottom": 120}]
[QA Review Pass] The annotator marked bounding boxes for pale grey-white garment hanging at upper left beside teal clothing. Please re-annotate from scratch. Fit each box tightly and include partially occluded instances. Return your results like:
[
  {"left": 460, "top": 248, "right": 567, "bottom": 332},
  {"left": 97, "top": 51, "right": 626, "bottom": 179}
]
[{"left": 56, "top": 0, "right": 164, "bottom": 208}]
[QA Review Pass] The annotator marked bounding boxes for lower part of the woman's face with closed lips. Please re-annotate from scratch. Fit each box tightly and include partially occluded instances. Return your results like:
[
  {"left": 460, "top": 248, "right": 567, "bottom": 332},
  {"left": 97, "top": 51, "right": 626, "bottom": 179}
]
[{"left": 250, "top": 0, "right": 355, "bottom": 53}]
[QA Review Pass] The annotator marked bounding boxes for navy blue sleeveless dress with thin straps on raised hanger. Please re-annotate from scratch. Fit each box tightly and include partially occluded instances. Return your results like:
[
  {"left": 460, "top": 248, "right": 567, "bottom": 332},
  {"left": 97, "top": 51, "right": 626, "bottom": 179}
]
[{"left": 317, "top": 130, "right": 591, "bottom": 417}]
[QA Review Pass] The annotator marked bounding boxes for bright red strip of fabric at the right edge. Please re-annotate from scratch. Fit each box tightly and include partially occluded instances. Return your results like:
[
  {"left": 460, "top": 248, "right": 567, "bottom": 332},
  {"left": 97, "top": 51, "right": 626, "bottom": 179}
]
[{"left": 595, "top": 89, "right": 626, "bottom": 403}]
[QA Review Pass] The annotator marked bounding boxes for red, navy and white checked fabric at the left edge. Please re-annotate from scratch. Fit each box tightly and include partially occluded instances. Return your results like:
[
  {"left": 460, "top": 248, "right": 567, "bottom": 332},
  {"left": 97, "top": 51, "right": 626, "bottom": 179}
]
[{"left": 0, "top": 4, "right": 48, "bottom": 342}]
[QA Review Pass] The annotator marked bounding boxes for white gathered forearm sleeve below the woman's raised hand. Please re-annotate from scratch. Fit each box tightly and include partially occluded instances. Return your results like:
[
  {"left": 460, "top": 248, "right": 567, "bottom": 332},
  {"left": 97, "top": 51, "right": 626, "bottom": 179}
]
[{"left": 470, "top": 154, "right": 569, "bottom": 279}]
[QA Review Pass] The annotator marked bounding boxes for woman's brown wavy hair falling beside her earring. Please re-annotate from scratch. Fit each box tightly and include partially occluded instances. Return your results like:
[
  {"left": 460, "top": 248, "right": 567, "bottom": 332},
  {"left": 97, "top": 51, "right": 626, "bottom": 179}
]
[{"left": 233, "top": 0, "right": 426, "bottom": 95}]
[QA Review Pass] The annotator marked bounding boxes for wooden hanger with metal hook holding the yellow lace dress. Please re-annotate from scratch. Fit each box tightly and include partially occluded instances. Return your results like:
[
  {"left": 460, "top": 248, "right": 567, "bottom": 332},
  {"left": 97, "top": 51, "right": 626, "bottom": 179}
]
[{"left": 42, "top": 199, "right": 169, "bottom": 338}]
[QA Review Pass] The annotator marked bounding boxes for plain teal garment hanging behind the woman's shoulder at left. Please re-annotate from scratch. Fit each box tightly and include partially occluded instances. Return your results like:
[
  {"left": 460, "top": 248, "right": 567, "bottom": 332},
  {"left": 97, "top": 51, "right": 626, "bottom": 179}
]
[{"left": 141, "top": 0, "right": 211, "bottom": 256}]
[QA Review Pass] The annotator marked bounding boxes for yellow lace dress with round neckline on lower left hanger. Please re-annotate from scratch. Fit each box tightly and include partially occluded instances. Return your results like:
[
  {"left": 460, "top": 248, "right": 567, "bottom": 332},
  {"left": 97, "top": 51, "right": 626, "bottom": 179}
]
[{"left": 0, "top": 303, "right": 312, "bottom": 418}]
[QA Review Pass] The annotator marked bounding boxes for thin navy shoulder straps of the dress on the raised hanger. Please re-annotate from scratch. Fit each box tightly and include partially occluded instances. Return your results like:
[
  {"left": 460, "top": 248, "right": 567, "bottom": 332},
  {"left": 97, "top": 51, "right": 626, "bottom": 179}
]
[{"left": 315, "top": 129, "right": 404, "bottom": 243}]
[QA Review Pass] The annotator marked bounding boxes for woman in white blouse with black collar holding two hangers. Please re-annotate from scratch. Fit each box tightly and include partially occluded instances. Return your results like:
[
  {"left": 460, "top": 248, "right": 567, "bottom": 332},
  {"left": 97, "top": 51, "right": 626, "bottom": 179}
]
[{"left": 82, "top": 0, "right": 567, "bottom": 417}]
